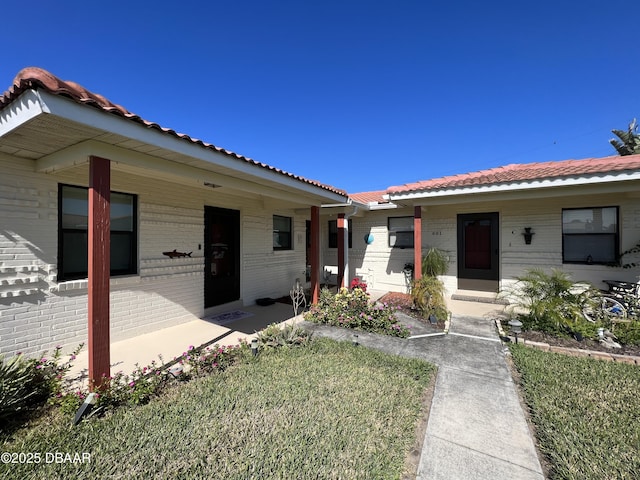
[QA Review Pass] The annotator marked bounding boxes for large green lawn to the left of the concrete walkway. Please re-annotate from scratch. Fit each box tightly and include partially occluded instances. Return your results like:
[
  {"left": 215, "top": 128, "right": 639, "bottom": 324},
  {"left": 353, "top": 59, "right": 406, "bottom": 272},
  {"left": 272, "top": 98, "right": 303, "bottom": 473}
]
[{"left": 0, "top": 339, "right": 435, "bottom": 479}]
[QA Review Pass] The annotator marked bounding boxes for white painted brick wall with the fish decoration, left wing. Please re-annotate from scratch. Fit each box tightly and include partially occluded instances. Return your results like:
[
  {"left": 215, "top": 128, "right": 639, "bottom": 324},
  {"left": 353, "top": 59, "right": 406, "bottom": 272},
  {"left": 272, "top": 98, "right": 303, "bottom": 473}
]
[{"left": 0, "top": 155, "right": 309, "bottom": 355}]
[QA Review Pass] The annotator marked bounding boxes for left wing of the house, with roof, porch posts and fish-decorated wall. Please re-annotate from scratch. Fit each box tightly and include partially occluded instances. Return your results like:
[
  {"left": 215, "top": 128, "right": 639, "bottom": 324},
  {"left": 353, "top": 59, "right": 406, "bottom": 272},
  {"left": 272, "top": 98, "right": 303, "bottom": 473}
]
[{"left": 0, "top": 68, "right": 348, "bottom": 378}]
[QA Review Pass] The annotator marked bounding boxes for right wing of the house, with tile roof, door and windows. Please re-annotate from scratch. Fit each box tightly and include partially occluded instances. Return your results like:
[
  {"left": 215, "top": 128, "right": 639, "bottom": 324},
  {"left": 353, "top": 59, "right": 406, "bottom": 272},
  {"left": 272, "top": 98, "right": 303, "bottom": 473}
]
[{"left": 322, "top": 155, "right": 640, "bottom": 297}]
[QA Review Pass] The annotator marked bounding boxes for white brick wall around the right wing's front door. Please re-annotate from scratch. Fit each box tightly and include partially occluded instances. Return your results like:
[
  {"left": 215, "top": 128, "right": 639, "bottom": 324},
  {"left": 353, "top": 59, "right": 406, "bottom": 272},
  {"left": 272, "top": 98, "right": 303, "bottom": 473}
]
[{"left": 321, "top": 193, "right": 640, "bottom": 294}]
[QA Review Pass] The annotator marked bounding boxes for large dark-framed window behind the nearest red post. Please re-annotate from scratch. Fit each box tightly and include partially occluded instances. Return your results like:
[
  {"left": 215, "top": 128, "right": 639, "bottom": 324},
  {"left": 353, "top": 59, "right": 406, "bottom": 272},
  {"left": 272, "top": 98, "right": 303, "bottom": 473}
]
[{"left": 58, "top": 185, "right": 138, "bottom": 281}]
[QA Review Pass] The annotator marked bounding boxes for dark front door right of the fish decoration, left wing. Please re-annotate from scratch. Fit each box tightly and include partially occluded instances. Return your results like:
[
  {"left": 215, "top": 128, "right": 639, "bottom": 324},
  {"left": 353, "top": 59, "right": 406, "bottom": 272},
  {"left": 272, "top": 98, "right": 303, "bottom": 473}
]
[{"left": 204, "top": 207, "right": 240, "bottom": 308}]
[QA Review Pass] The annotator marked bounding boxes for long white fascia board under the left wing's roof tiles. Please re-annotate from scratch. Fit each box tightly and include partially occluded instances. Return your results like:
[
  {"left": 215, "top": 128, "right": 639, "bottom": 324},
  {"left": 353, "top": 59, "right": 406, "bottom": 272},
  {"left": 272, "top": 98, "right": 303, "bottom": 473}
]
[{"left": 35, "top": 92, "right": 345, "bottom": 202}]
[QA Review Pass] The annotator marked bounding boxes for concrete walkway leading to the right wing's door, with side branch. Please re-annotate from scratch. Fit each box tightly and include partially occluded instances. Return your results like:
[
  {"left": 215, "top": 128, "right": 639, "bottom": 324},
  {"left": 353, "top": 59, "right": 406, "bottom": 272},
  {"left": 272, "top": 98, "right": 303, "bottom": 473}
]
[{"left": 304, "top": 302, "right": 544, "bottom": 480}]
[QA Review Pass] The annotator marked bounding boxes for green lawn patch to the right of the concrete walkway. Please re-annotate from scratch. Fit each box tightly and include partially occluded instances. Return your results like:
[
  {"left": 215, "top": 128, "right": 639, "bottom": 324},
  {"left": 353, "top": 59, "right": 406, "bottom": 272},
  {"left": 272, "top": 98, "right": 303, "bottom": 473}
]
[{"left": 510, "top": 345, "right": 640, "bottom": 480}]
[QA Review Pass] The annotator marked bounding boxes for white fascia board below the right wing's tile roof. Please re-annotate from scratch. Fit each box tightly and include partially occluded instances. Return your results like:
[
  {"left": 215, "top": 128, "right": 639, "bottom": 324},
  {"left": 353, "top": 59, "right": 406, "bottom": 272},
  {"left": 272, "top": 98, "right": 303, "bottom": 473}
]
[{"left": 389, "top": 171, "right": 640, "bottom": 202}]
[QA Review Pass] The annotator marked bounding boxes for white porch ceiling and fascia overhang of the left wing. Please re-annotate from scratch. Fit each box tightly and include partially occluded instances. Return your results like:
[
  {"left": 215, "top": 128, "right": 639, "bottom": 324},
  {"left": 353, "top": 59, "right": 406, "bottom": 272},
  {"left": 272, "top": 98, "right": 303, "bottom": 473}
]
[{"left": 0, "top": 68, "right": 347, "bottom": 207}]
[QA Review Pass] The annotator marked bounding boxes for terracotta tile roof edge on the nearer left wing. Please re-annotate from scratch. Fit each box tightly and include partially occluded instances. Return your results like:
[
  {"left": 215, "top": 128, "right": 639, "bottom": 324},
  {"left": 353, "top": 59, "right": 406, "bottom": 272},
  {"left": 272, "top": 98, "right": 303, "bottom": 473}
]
[{"left": 0, "top": 67, "right": 347, "bottom": 196}]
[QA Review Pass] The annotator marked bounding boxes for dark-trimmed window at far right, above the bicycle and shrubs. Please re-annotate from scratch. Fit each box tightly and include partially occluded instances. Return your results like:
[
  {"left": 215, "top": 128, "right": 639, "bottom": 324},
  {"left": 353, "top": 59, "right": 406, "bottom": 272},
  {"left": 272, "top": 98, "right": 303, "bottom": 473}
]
[{"left": 562, "top": 207, "right": 620, "bottom": 264}]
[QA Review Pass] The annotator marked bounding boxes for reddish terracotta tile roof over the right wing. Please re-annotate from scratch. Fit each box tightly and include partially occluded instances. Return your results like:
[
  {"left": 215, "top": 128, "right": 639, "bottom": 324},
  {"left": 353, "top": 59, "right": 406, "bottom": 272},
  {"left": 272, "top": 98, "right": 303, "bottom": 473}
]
[{"left": 387, "top": 155, "right": 640, "bottom": 194}]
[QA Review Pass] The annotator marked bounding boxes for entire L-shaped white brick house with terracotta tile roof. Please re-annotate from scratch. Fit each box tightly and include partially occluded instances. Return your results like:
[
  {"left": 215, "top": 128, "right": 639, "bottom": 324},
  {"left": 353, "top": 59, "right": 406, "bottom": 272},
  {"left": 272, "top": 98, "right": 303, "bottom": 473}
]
[{"left": 0, "top": 68, "right": 640, "bottom": 384}]
